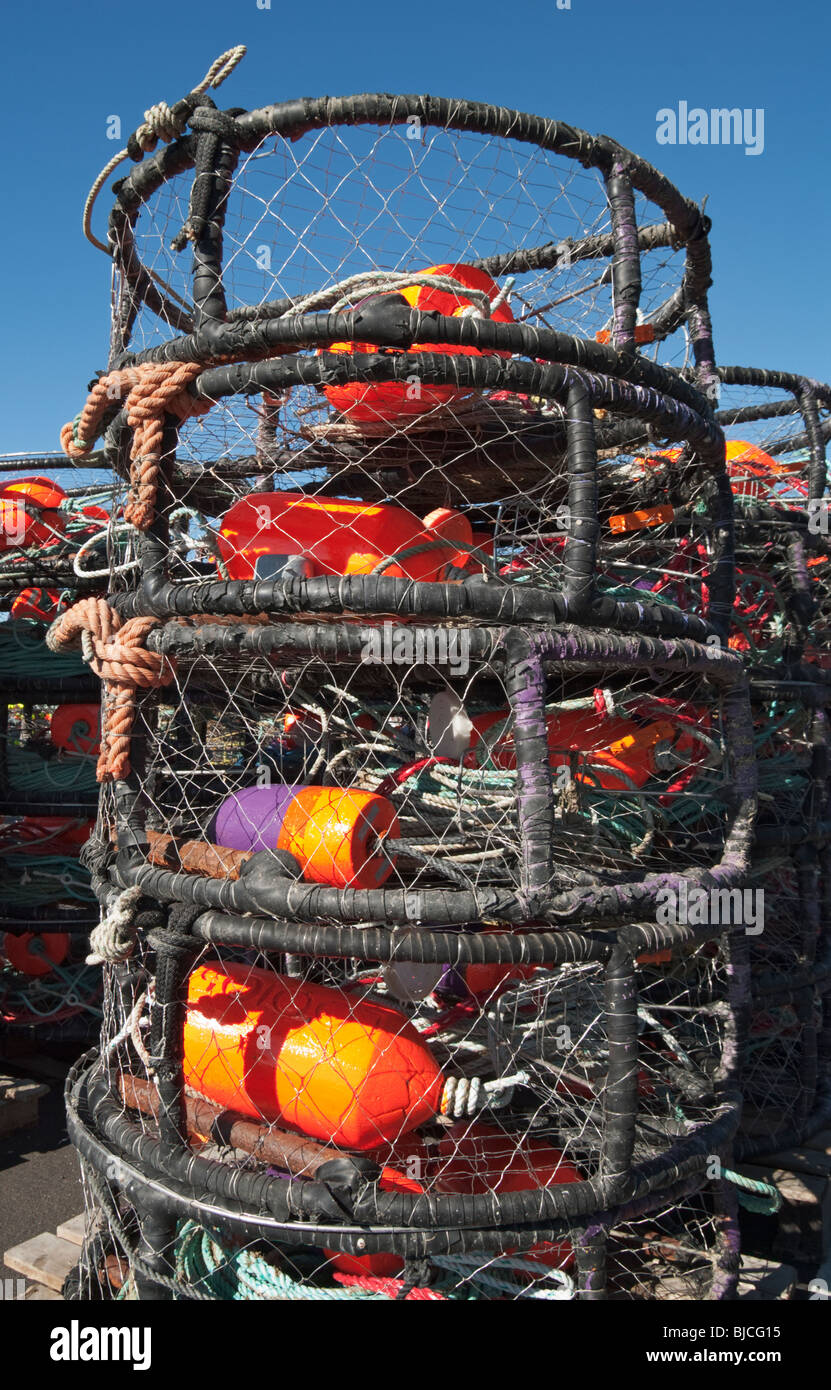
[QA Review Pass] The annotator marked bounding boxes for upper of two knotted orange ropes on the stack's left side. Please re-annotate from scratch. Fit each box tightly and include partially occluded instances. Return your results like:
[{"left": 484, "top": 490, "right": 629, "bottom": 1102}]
[{"left": 61, "top": 361, "right": 211, "bottom": 531}]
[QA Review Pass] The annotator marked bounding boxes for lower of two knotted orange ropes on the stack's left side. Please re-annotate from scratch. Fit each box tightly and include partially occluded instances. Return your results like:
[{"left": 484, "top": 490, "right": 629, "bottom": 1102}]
[{"left": 46, "top": 598, "right": 175, "bottom": 783}]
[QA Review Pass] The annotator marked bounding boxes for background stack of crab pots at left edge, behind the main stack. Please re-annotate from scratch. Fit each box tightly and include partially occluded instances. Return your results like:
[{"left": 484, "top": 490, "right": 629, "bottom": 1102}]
[{"left": 0, "top": 455, "right": 113, "bottom": 1045}]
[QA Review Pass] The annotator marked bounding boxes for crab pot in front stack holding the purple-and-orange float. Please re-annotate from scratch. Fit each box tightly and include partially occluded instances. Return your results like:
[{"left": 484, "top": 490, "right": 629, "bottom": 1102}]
[{"left": 100, "top": 621, "right": 755, "bottom": 926}]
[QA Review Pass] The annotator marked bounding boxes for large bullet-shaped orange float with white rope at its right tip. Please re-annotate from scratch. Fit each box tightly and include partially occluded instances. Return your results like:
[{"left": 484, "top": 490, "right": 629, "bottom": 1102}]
[{"left": 183, "top": 962, "right": 443, "bottom": 1152}]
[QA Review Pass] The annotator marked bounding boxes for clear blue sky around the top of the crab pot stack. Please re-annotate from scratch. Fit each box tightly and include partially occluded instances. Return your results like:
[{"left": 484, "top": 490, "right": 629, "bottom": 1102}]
[{"left": 0, "top": 0, "right": 831, "bottom": 452}]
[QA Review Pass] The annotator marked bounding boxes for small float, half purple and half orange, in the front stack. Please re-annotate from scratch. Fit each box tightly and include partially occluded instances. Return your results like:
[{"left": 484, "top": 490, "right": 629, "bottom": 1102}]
[{"left": 208, "top": 784, "right": 399, "bottom": 888}]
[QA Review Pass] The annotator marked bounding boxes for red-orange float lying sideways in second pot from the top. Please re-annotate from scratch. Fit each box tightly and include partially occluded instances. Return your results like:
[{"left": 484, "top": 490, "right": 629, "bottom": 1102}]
[{"left": 218, "top": 492, "right": 472, "bottom": 580}]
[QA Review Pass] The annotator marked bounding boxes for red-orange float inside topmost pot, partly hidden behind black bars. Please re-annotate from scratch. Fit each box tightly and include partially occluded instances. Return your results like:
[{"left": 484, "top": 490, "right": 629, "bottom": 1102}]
[{"left": 324, "top": 264, "right": 514, "bottom": 425}]
